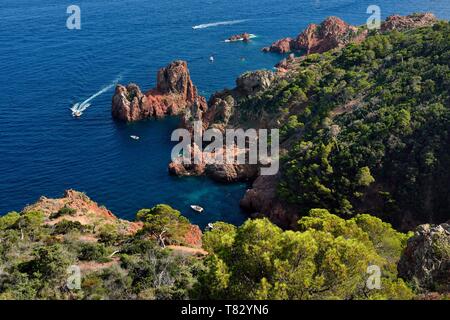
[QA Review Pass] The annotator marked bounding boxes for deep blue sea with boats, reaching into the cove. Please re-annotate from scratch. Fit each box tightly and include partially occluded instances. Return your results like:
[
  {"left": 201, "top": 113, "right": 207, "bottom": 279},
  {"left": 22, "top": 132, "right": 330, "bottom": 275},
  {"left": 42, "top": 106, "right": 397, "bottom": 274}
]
[{"left": 0, "top": 0, "right": 450, "bottom": 225}]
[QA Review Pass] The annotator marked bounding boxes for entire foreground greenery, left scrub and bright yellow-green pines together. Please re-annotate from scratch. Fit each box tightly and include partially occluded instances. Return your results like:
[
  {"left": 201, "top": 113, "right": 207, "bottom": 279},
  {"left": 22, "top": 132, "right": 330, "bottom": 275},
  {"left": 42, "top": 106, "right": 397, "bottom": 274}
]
[{"left": 0, "top": 205, "right": 413, "bottom": 299}]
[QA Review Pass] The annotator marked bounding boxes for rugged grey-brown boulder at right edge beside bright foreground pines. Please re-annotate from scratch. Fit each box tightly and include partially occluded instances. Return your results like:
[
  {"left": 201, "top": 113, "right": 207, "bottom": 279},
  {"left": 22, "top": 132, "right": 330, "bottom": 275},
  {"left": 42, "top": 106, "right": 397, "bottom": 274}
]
[{"left": 398, "top": 221, "right": 450, "bottom": 292}]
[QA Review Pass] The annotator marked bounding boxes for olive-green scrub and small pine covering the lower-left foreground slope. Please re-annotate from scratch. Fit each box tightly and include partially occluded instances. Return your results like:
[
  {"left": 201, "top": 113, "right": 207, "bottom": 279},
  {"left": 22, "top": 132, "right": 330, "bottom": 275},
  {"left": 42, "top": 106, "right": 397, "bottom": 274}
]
[{"left": 0, "top": 206, "right": 202, "bottom": 299}]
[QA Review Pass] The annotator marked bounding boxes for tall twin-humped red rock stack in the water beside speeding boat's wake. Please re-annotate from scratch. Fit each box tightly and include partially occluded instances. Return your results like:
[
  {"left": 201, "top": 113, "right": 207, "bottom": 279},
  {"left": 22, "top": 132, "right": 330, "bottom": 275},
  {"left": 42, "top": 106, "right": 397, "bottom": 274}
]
[{"left": 111, "top": 61, "right": 207, "bottom": 122}]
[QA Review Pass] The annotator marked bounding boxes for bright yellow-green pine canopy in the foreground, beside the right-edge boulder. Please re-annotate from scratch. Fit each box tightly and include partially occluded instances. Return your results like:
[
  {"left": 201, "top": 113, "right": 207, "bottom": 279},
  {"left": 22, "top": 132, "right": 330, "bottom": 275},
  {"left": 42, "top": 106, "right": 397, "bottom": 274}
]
[{"left": 197, "top": 209, "right": 413, "bottom": 299}]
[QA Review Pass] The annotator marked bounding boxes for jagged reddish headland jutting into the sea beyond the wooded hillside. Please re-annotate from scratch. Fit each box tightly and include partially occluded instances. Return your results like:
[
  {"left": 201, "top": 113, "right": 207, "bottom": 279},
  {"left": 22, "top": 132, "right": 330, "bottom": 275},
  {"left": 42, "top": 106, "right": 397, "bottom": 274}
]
[{"left": 263, "top": 17, "right": 367, "bottom": 54}]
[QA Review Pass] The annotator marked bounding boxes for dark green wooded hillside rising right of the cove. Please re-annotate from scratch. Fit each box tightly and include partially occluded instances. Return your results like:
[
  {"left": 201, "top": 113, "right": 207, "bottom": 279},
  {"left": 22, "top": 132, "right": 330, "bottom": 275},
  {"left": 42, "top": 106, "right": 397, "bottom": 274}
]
[{"left": 254, "top": 22, "right": 450, "bottom": 226}]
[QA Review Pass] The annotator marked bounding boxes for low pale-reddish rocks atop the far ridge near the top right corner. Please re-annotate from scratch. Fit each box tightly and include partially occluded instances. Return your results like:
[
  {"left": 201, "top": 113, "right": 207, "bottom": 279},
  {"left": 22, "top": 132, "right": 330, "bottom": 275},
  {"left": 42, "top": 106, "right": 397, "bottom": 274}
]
[{"left": 381, "top": 13, "right": 438, "bottom": 32}]
